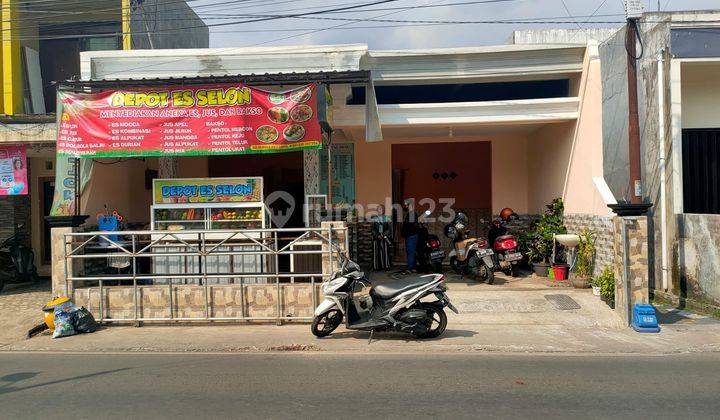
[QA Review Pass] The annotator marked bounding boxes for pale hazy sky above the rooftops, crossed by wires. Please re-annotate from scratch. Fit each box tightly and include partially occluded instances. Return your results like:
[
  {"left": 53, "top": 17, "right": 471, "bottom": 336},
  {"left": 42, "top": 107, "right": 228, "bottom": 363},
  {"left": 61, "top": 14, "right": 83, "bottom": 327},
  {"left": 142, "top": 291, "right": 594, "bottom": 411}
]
[{"left": 188, "top": 0, "right": 720, "bottom": 49}]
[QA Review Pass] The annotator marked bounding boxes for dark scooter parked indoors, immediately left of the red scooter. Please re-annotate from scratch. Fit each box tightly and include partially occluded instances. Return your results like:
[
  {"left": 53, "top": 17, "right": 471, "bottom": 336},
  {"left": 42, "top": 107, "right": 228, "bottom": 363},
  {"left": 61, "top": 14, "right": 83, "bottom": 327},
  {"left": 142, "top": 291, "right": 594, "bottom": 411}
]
[{"left": 445, "top": 213, "right": 496, "bottom": 284}]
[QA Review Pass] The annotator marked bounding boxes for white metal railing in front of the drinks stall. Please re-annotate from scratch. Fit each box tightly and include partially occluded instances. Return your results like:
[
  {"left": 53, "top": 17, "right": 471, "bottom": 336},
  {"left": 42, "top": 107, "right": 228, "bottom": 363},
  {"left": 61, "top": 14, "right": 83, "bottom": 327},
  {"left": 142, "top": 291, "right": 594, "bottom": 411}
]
[{"left": 63, "top": 226, "right": 348, "bottom": 323}]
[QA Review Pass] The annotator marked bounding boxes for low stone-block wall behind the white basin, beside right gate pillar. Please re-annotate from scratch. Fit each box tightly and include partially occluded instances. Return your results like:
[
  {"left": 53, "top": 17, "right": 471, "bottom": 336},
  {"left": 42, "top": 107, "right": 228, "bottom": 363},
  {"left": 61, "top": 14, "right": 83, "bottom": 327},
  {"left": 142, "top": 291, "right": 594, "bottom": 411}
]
[{"left": 563, "top": 214, "right": 613, "bottom": 276}]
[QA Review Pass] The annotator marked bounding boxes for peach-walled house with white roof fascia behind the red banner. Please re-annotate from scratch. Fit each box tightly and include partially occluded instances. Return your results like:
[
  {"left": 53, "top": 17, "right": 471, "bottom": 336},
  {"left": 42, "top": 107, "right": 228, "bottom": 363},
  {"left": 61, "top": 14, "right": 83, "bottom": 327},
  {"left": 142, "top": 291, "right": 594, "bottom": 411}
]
[{"left": 45, "top": 41, "right": 607, "bottom": 278}]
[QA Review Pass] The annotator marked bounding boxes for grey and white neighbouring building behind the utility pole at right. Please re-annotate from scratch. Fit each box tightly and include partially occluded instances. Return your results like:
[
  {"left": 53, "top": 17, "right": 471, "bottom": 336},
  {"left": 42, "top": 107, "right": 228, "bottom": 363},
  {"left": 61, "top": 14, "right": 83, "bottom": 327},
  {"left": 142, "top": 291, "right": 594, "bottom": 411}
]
[{"left": 600, "top": 11, "right": 720, "bottom": 309}]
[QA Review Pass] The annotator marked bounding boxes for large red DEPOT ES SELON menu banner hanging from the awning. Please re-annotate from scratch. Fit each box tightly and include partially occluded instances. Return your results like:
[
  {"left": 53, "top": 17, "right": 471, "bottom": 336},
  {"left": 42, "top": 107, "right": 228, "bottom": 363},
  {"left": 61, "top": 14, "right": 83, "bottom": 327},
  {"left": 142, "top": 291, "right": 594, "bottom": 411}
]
[{"left": 57, "top": 84, "right": 325, "bottom": 158}]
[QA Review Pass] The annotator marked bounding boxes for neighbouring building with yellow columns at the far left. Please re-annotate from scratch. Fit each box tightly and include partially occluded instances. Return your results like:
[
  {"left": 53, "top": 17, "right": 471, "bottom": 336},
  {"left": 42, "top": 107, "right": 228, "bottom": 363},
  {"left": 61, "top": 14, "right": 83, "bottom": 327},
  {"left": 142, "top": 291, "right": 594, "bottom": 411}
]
[{"left": 0, "top": 0, "right": 208, "bottom": 274}]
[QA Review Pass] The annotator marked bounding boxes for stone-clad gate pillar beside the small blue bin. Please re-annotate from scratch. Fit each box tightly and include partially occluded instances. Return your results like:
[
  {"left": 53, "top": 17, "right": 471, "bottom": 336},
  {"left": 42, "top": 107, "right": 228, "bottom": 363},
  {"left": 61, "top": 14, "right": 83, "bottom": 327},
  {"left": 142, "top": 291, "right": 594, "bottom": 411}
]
[{"left": 613, "top": 216, "right": 650, "bottom": 325}]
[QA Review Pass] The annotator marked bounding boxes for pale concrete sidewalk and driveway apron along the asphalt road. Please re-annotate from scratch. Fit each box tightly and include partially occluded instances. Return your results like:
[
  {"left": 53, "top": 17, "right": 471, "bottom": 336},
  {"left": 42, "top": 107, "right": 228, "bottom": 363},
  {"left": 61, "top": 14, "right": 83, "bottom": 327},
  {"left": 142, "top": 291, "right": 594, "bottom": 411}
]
[{"left": 0, "top": 278, "right": 720, "bottom": 354}]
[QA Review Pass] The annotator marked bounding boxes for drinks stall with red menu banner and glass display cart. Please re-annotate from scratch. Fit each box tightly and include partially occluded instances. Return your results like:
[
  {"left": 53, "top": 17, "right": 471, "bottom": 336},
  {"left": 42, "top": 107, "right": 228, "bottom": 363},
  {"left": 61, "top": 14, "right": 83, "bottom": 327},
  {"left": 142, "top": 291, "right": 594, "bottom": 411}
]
[{"left": 50, "top": 72, "right": 367, "bottom": 285}]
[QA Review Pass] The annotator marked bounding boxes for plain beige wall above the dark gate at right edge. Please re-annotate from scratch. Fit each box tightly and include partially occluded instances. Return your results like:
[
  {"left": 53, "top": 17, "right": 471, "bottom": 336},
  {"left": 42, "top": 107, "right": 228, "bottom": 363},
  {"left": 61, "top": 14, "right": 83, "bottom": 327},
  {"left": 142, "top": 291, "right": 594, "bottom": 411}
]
[{"left": 681, "top": 63, "right": 720, "bottom": 128}]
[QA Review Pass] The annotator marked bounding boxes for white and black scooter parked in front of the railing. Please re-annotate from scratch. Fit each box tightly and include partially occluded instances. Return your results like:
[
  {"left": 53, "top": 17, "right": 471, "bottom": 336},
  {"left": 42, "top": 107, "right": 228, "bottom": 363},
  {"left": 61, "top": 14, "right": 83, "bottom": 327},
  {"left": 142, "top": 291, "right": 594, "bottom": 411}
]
[{"left": 310, "top": 254, "right": 458, "bottom": 338}]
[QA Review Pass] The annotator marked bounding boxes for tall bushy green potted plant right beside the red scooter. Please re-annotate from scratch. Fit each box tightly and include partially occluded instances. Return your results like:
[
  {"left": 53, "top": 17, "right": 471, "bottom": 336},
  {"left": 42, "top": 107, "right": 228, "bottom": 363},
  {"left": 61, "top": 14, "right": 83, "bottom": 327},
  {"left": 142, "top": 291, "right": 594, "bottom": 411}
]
[{"left": 520, "top": 198, "right": 567, "bottom": 277}]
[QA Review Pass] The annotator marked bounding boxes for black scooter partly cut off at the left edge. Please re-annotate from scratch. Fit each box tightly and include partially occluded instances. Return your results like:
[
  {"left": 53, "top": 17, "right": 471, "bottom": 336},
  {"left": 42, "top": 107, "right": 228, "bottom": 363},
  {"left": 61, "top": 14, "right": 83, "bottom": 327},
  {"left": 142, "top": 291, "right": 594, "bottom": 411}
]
[{"left": 0, "top": 226, "right": 38, "bottom": 292}]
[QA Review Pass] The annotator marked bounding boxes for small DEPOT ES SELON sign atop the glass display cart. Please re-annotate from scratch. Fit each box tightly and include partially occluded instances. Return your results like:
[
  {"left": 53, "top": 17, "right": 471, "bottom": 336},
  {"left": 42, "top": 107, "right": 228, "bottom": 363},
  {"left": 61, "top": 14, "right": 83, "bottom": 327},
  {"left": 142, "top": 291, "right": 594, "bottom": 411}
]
[{"left": 153, "top": 177, "right": 262, "bottom": 204}]
